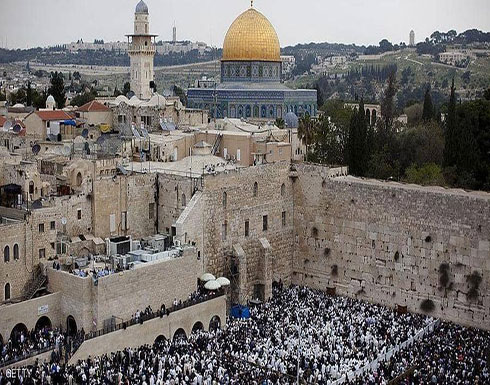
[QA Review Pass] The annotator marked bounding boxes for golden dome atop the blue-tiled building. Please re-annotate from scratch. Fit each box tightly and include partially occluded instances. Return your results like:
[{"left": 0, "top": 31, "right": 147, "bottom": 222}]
[{"left": 222, "top": 8, "right": 281, "bottom": 62}]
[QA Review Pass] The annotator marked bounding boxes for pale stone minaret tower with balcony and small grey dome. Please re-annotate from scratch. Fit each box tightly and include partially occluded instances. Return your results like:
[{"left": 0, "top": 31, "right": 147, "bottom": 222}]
[{"left": 126, "top": 0, "right": 157, "bottom": 100}]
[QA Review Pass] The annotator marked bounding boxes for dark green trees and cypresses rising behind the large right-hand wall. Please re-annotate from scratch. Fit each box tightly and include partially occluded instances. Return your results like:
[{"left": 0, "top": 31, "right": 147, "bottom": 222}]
[{"left": 298, "top": 73, "right": 490, "bottom": 191}]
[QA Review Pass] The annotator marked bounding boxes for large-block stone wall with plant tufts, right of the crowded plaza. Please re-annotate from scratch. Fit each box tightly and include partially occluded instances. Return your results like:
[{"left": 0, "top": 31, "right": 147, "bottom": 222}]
[{"left": 293, "top": 165, "right": 490, "bottom": 329}]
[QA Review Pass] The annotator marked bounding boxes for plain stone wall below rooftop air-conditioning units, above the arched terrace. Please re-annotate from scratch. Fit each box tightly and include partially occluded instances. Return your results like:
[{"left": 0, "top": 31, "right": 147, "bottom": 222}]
[{"left": 47, "top": 248, "right": 202, "bottom": 332}]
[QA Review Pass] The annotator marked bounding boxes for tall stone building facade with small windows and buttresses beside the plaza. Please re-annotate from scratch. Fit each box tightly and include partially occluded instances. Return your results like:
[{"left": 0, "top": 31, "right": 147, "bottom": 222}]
[{"left": 177, "top": 162, "right": 294, "bottom": 301}]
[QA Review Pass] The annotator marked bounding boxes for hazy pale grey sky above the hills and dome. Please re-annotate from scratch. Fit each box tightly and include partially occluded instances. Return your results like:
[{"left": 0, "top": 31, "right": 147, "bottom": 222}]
[{"left": 0, "top": 0, "right": 490, "bottom": 48}]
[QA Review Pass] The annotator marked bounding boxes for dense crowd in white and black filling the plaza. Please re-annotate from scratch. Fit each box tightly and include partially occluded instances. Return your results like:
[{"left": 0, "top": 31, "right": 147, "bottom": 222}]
[{"left": 0, "top": 286, "right": 490, "bottom": 385}]
